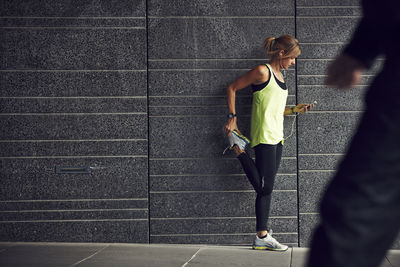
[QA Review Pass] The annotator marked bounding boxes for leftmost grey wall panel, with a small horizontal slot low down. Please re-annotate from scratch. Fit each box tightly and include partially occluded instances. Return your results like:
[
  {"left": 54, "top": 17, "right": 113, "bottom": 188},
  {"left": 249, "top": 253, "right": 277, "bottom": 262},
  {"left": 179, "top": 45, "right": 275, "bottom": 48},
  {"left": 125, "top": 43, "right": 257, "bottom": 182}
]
[{"left": 0, "top": 0, "right": 149, "bottom": 242}]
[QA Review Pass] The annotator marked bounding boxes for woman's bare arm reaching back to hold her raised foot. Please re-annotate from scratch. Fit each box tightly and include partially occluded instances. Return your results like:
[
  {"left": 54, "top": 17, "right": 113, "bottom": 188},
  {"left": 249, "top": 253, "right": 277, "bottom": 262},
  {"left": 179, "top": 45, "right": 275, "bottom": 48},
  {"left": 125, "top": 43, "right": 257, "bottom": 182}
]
[{"left": 224, "top": 65, "right": 270, "bottom": 135}]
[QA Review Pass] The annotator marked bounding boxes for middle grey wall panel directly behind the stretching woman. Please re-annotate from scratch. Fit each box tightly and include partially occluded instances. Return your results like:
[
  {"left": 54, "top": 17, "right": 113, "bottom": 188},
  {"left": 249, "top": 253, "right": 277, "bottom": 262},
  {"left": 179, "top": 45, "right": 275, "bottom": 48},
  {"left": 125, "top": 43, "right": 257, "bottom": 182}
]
[{"left": 148, "top": 0, "right": 298, "bottom": 245}]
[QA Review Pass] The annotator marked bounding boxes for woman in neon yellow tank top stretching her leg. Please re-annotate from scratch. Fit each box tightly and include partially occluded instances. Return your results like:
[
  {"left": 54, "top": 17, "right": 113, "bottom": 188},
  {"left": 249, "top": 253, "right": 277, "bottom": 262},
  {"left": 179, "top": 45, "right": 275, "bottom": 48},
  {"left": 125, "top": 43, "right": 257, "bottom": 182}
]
[{"left": 224, "top": 35, "right": 314, "bottom": 251}]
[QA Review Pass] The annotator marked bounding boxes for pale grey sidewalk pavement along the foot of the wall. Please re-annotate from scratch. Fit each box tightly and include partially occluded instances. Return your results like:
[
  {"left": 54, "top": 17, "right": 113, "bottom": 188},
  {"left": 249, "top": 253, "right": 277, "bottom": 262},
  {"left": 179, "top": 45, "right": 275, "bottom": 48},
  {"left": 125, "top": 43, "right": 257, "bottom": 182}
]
[{"left": 0, "top": 242, "right": 400, "bottom": 267}]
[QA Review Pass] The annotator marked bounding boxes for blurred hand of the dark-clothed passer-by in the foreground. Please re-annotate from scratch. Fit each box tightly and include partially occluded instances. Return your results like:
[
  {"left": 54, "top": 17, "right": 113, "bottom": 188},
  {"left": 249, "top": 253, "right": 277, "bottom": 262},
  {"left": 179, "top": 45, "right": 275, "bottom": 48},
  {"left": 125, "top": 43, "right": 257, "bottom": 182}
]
[{"left": 325, "top": 54, "right": 364, "bottom": 89}]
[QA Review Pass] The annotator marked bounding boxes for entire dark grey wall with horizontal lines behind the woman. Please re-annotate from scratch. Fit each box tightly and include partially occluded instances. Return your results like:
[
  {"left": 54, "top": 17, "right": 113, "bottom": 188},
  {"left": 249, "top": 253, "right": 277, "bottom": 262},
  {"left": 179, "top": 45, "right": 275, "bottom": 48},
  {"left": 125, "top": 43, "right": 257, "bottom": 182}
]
[{"left": 0, "top": 0, "right": 398, "bottom": 249}]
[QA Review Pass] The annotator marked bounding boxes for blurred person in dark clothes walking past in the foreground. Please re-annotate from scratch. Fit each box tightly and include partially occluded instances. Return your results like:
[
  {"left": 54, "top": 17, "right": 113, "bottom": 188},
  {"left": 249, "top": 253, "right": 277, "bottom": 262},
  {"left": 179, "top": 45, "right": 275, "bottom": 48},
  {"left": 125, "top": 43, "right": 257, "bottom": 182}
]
[{"left": 307, "top": 0, "right": 400, "bottom": 267}]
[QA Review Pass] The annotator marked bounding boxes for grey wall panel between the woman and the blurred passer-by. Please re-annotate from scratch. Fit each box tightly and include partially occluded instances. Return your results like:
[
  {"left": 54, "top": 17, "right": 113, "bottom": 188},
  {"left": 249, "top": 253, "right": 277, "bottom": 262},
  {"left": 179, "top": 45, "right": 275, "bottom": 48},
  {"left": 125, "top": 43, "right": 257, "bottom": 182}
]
[{"left": 296, "top": 0, "right": 362, "bottom": 246}]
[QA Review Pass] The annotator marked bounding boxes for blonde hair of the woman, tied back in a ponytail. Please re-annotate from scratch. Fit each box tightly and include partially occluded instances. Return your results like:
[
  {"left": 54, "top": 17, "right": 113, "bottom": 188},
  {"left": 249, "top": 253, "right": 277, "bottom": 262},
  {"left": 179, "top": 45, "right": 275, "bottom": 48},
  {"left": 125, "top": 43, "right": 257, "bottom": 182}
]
[{"left": 264, "top": 34, "right": 301, "bottom": 60}]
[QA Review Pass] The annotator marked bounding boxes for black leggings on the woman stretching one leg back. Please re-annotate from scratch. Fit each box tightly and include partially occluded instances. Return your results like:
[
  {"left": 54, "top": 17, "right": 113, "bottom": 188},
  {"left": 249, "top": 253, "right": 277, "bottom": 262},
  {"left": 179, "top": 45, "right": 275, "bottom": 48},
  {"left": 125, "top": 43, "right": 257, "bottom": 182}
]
[{"left": 238, "top": 143, "right": 282, "bottom": 231}]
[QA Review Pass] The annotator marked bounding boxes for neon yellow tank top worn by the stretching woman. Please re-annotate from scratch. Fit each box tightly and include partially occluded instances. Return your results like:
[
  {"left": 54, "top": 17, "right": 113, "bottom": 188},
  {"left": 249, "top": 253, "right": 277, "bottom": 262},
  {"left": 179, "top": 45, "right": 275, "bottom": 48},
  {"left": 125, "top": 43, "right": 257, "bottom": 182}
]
[{"left": 250, "top": 64, "right": 288, "bottom": 147}]
